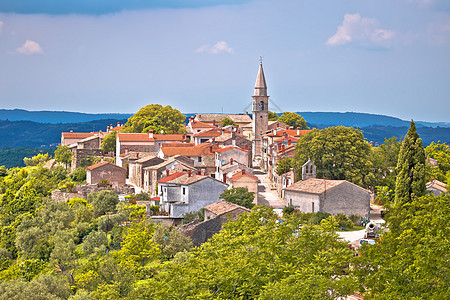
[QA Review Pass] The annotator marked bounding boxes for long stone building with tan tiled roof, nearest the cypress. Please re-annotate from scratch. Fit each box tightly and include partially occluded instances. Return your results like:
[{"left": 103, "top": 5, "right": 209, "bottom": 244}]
[{"left": 283, "top": 178, "right": 371, "bottom": 217}]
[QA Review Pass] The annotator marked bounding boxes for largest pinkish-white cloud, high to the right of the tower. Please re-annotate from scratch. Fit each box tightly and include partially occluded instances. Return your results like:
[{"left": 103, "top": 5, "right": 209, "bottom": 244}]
[{"left": 326, "top": 13, "right": 395, "bottom": 46}]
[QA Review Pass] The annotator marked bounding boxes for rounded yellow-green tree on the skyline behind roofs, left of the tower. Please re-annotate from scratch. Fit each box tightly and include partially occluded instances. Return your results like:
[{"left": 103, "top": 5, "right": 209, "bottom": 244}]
[{"left": 122, "top": 104, "right": 186, "bottom": 133}]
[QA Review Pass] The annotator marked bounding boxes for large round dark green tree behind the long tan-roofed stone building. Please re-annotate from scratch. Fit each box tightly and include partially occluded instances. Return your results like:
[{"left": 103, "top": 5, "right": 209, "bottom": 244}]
[{"left": 294, "top": 126, "right": 373, "bottom": 186}]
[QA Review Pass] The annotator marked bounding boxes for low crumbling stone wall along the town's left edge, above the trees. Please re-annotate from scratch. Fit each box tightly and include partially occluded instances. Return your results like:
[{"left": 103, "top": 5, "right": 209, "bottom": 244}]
[{"left": 51, "top": 184, "right": 135, "bottom": 202}]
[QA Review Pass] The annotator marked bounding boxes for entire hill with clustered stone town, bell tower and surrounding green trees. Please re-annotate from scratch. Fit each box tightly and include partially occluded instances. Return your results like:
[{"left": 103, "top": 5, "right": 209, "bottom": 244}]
[{"left": 0, "top": 62, "right": 450, "bottom": 299}]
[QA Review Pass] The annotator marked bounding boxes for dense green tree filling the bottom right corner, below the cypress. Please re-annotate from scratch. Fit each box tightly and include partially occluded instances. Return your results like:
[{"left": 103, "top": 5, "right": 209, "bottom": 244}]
[{"left": 354, "top": 193, "right": 450, "bottom": 299}]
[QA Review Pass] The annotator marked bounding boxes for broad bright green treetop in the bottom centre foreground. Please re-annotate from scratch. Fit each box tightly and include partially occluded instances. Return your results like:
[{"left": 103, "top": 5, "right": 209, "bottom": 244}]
[{"left": 130, "top": 207, "right": 355, "bottom": 299}]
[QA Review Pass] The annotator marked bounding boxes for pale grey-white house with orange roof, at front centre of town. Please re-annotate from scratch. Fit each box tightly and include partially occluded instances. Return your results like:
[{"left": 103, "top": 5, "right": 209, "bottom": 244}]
[{"left": 158, "top": 172, "right": 228, "bottom": 218}]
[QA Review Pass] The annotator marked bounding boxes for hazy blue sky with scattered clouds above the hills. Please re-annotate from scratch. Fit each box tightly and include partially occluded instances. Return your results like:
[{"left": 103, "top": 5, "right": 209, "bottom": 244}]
[{"left": 0, "top": 0, "right": 450, "bottom": 122}]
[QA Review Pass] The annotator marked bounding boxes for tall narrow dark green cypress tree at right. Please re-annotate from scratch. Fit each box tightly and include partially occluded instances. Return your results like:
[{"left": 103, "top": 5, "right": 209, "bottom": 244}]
[{"left": 390, "top": 121, "right": 426, "bottom": 229}]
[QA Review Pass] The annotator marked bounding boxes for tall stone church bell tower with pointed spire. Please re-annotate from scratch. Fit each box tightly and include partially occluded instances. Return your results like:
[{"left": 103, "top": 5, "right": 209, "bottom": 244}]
[{"left": 252, "top": 60, "right": 269, "bottom": 157}]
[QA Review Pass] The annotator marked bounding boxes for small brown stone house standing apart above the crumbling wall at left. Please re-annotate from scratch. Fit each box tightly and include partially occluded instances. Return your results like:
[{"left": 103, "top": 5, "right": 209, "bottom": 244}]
[{"left": 86, "top": 161, "right": 127, "bottom": 186}]
